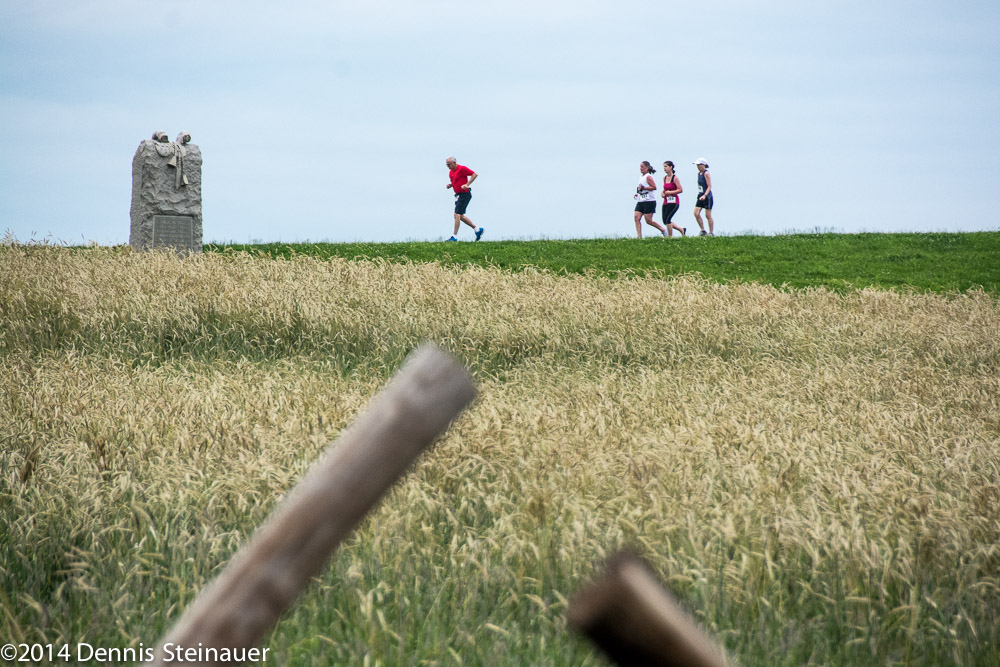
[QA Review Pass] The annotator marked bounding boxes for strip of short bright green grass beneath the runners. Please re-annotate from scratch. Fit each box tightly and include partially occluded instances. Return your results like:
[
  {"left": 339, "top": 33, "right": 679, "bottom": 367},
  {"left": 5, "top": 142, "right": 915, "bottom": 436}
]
[{"left": 206, "top": 232, "right": 1000, "bottom": 294}]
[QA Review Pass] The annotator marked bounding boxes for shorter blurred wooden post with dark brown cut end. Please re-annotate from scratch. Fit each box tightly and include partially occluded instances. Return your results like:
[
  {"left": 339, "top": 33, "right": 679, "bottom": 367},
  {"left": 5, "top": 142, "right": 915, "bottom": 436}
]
[{"left": 568, "top": 552, "right": 727, "bottom": 667}]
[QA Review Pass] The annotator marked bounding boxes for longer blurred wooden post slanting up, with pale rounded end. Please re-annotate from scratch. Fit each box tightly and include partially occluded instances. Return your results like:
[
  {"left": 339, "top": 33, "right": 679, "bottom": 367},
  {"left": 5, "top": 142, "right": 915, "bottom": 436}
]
[{"left": 152, "top": 346, "right": 476, "bottom": 665}]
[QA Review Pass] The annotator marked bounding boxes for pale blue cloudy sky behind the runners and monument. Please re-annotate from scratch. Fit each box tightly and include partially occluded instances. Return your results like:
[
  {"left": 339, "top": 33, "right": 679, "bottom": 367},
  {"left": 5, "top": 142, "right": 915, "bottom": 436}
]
[{"left": 0, "top": 0, "right": 1000, "bottom": 245}]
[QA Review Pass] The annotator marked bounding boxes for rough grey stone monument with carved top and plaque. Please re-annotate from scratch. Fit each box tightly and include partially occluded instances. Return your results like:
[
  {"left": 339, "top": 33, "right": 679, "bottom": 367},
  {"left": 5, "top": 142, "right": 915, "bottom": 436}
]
[{"left": 128, "top": 132, "right": 202, "bottom": 253}]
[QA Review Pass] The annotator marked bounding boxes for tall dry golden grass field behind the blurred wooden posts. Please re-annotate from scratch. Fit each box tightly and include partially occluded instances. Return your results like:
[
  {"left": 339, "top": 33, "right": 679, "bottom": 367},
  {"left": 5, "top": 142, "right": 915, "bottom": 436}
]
[{"left": 0, "top": 245, "right": 1000, "bottom": 665}]
